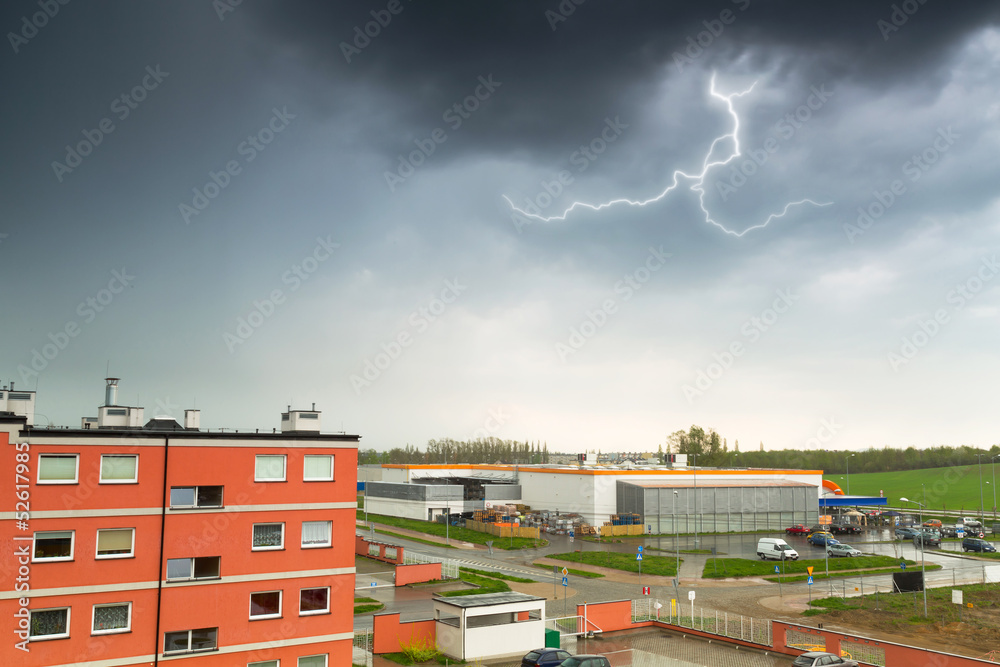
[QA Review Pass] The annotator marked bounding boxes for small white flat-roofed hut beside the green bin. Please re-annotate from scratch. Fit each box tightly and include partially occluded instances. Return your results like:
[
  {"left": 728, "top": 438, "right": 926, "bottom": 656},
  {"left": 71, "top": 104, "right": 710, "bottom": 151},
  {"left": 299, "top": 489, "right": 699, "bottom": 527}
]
[{"left": 434, "top": 593, "right": 545, "bottom": 661}]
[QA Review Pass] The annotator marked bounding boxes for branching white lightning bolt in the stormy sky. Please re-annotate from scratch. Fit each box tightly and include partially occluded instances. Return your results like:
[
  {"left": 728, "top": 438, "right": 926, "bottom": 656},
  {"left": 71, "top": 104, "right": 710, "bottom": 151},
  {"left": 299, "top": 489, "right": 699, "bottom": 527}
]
[{"left": 503, "top": 72, "right": 833, "bottom": 237}]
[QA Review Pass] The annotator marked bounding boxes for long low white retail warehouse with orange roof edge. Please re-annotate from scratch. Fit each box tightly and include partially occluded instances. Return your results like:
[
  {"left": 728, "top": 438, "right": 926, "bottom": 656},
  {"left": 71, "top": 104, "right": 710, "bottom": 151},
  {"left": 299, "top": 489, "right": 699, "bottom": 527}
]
[{"left": 359, "top": 465, "right": 824, "bottom": 533}]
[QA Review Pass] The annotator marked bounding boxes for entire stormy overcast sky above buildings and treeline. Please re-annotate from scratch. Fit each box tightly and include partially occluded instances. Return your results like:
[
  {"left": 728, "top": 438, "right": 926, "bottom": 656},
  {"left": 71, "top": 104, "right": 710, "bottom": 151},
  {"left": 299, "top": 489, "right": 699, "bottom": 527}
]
[{"left": 0, "top": 0, "right": 1000, "bottom": 451}]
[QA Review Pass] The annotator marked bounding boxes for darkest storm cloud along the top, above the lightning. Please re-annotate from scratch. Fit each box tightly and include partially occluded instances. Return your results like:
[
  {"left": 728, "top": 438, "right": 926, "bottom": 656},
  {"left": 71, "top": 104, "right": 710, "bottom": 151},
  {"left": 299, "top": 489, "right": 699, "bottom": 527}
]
[{"left": 253, "top": 0, "right": 1000, "bottom": 160}]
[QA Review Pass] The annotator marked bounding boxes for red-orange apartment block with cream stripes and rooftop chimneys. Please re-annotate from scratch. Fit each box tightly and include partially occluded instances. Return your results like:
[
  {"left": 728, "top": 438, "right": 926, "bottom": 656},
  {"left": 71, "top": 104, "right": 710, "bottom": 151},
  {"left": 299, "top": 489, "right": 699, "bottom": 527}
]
[{"left": 0, "top": 378, "right": 359, "bottom": 667}]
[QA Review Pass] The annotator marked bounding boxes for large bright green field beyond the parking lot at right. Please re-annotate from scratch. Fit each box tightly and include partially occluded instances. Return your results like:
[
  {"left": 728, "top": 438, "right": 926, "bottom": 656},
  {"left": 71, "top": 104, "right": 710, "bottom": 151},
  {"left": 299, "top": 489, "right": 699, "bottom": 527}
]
[{"left": 823, "top": 463, "right": 1000, "bottom": 521}]
